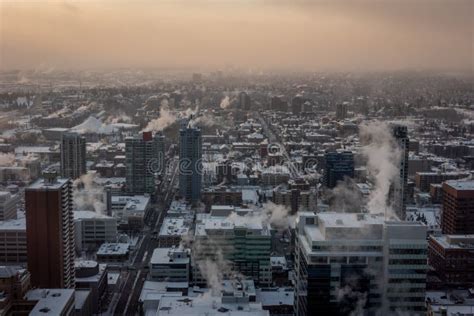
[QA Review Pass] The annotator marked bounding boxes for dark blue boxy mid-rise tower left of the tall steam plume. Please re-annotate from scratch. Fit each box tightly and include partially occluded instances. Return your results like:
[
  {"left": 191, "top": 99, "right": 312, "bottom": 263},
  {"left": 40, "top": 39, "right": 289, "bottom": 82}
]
[{"left": 323, "top": 151, "right": 354, "bottom": 189}]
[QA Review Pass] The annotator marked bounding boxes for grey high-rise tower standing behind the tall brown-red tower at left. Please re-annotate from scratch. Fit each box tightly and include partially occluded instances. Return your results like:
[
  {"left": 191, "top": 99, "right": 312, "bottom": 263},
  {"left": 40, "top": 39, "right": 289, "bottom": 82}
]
[{"left": 61, "top": 133, "right": 86, "bottom": 179}]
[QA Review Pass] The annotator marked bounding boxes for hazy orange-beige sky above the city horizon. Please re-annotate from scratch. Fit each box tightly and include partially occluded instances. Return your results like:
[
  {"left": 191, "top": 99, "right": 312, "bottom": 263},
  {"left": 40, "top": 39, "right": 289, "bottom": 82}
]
[{"left": 0, "top": 0, "right": 474, "bottom": 70}]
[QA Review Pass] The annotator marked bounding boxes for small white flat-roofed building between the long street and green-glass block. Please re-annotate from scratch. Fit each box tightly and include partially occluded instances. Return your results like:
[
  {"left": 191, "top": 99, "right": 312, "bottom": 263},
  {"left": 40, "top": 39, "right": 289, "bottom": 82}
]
[{"left": 150, "top": 247, "right": 190, "bottom": 282}]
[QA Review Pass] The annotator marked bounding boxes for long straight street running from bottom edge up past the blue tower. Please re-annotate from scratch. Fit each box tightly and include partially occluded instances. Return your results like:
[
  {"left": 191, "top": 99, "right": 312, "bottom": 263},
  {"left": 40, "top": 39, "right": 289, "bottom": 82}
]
[{"left": 113, "top": 158, "right": 178, "bottom": 315}]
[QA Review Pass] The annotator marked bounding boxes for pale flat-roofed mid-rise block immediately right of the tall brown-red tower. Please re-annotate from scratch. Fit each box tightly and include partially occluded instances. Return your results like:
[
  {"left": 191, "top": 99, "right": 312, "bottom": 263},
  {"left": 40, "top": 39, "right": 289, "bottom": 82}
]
[{"left": 74, "top": 211, "right": 117, "bottom": 251}]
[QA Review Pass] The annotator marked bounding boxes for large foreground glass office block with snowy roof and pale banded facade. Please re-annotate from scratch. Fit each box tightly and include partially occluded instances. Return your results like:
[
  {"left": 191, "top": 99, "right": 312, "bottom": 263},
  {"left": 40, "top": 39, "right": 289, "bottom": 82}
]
[{"left": 295, "top": 212, "right": 427, "bottom": 316}]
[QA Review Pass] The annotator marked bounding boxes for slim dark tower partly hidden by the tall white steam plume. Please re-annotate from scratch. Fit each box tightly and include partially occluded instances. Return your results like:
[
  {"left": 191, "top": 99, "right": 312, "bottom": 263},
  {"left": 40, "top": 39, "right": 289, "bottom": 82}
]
[{"left": 390, "top": 125, "right": 410, "bottom": 220}]
